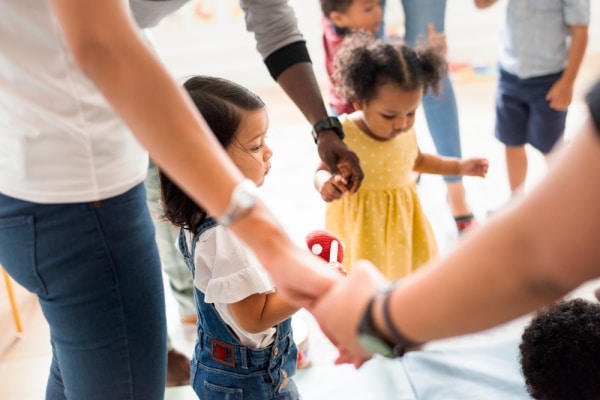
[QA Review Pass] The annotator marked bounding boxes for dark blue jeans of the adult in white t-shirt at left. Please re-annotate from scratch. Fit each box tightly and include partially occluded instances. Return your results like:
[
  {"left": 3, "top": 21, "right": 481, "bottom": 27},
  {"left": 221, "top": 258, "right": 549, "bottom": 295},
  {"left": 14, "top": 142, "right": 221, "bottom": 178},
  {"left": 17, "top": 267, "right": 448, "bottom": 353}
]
[{"left": 0, "top": 184, "right": 167, "bottom": 400}]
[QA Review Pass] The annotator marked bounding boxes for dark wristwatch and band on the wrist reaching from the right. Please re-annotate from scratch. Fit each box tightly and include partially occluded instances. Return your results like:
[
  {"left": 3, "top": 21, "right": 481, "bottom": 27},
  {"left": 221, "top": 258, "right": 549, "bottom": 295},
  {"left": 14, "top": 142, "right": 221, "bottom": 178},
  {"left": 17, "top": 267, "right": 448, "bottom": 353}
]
[{"left": 358, "top": 286, "right": 420, "bottom": 358}]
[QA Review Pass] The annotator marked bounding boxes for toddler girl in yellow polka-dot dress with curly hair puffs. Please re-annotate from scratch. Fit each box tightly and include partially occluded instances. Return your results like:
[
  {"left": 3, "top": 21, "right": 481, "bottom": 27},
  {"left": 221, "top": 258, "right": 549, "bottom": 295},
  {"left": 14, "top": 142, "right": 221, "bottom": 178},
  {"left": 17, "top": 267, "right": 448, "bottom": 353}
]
[{"left": 315, "top": 33, "right": 488, "bottom": 279}]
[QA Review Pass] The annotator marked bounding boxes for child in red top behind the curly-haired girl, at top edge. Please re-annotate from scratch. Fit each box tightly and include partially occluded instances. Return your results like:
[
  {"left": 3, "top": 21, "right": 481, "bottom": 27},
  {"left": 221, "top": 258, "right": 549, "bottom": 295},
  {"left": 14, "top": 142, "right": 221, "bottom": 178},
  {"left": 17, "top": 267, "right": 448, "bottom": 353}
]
[{"left": 320, "top": 0, "right": 383, "bottom": 116}]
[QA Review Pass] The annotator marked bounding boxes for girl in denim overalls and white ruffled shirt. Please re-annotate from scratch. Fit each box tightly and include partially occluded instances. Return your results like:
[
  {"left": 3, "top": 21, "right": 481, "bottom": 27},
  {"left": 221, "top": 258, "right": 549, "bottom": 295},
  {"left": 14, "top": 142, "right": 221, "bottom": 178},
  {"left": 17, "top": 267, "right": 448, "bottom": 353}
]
[{"left": 160, "top": 76, "right": 300, "bottom": 399}]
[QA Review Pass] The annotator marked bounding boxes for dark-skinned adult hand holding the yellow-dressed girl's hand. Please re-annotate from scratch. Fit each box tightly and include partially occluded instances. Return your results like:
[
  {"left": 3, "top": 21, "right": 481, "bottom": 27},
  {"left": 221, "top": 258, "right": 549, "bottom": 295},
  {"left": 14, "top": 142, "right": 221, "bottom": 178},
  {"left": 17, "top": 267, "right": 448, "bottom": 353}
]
[{"left": 317, "top": 130, "right": 364, "bottom": 193}]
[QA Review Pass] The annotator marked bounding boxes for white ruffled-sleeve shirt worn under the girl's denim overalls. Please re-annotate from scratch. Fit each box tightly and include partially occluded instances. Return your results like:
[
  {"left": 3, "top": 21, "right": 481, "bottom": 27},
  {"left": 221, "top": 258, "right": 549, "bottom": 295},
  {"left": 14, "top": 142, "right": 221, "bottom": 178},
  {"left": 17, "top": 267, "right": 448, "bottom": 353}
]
[{"left": 186, "top": 225, "right": 276, "bottom": 349}]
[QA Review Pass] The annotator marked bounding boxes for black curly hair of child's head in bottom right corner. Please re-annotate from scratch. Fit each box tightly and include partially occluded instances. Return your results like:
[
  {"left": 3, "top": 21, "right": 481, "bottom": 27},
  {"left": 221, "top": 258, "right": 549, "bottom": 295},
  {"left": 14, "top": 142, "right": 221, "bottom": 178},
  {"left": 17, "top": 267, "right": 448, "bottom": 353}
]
[{"left": 519, "top": 299, "right": 600, "bottom": 400}]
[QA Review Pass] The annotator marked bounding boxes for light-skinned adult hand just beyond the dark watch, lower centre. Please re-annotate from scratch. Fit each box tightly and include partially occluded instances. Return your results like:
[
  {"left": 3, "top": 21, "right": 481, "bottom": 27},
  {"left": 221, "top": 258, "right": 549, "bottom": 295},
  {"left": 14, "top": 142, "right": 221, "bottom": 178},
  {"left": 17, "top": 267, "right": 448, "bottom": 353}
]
[{"left": 309, "top": 261, "right": 387, "bottom": 367}]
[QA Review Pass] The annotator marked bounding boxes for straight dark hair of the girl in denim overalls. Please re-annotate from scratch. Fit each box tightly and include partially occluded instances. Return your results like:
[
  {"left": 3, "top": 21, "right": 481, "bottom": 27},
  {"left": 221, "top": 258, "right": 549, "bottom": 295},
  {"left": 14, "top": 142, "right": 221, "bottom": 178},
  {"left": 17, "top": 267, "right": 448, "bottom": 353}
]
[{"left": 159, "top": 76, "right": 265, "bottom": 231}]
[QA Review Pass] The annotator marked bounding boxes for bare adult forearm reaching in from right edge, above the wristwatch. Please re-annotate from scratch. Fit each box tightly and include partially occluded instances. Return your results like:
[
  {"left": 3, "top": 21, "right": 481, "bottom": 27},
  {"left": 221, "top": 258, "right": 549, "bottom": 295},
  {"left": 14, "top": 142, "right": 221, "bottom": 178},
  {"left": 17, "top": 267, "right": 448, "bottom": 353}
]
[{"left": 392, "top": 123, "right": 600, "bottom": 341}]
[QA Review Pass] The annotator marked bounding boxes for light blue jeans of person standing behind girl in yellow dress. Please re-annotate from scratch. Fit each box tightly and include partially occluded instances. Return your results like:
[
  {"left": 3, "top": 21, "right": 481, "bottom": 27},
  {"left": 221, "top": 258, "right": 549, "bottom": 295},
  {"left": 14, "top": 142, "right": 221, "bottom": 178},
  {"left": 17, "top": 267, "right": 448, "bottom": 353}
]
[{"left": 379, "top": 0, "right": 462, "bottom": 183}]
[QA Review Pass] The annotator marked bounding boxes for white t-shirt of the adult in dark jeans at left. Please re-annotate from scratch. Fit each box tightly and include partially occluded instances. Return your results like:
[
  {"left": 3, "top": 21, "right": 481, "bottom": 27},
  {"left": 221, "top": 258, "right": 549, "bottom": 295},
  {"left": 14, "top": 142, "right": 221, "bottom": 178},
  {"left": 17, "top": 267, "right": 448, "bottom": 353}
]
[{"left": 0, "top": 0, "right": 148, "bottom": 203}]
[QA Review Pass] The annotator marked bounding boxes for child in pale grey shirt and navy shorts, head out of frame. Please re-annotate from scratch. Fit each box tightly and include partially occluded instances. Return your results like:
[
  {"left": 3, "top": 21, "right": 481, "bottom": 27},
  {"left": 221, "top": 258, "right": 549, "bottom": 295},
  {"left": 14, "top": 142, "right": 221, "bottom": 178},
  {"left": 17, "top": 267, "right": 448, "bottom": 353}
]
[{"left": 475, "top": 0, "right": 590, "bottom": 196}]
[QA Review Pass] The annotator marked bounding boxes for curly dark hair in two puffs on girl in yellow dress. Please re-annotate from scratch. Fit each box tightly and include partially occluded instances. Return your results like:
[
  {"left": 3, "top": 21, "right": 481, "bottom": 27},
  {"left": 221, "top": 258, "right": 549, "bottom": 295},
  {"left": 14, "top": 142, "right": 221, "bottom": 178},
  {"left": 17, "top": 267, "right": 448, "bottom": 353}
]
[{"left": 333, "top": 31, "right": 447, "bottom": 103}]
